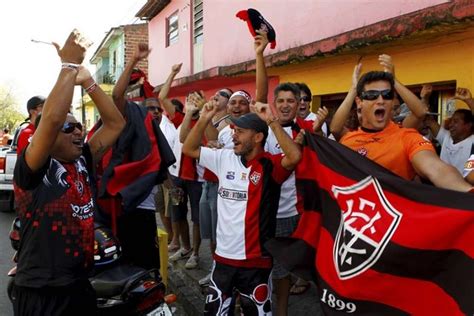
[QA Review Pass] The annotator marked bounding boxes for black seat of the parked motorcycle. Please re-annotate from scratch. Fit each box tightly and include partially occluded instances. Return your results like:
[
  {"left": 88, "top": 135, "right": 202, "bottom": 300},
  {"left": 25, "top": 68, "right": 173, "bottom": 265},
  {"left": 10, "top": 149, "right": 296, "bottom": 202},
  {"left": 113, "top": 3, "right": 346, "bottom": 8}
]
[{"left": 89, "top": 265, "right": 148, "bottom": 298}]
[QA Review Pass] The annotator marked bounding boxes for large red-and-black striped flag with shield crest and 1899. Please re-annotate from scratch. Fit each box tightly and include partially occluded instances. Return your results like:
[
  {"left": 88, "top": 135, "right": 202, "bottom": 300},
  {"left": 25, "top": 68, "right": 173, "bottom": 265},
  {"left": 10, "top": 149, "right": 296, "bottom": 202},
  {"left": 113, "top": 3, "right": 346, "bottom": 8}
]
[{"left": 267, "top": 135, "right": 474, "bottom": 315}]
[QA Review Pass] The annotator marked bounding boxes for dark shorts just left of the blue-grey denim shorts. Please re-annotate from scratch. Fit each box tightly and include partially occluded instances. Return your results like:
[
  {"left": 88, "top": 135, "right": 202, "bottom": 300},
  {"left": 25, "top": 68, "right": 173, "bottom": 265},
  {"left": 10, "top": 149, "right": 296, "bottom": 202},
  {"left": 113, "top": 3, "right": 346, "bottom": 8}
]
[{"left": 171, "top": 176, "right": 202, "bottom": 224}]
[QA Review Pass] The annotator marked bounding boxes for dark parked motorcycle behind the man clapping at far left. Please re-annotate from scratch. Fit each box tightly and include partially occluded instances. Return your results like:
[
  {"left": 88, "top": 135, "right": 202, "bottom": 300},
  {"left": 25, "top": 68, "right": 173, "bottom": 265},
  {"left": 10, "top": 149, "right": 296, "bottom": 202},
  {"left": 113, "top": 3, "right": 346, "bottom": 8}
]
[{"left": 7, "top": 218, "right": 176, "bottom": 316}]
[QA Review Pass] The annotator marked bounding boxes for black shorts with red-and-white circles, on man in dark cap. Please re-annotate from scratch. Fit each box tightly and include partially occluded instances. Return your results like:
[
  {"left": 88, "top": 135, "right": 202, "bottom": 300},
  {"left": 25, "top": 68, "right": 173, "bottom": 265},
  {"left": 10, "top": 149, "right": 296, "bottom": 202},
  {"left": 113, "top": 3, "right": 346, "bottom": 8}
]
[{"left": 204, "top": 262, "right": 272, "bottom": 316}]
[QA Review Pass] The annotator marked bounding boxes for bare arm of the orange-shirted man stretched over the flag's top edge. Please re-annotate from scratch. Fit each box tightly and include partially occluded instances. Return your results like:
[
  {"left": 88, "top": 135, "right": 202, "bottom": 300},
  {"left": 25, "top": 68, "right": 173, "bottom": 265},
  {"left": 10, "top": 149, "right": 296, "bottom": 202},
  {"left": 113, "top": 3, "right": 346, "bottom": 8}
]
[{"left": 411, "top": 150, "right": 472, "bottom": 192}]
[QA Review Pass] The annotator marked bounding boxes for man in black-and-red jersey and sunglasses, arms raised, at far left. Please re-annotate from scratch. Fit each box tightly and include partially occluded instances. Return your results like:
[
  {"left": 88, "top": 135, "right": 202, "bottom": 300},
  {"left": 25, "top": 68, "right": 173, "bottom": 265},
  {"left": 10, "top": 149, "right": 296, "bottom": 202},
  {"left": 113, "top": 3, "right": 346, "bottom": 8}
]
[{"left": 13, "top": 30, "right": 125, "bottom": 315}]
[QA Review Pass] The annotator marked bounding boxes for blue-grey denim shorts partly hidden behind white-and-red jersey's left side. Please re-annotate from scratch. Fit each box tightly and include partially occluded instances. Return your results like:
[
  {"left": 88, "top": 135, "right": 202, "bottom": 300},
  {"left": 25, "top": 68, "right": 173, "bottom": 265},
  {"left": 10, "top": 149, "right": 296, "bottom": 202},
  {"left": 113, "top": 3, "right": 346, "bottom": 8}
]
[{"left": 199, "top": 181, "right": 219, "bottom": 242}]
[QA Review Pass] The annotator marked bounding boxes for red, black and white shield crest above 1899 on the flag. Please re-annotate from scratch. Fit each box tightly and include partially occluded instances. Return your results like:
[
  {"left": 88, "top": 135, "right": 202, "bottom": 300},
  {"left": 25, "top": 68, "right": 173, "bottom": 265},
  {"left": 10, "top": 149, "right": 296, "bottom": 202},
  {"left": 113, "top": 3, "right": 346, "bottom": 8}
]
[{"left": 332, "top": 176, "right": 402, "bottom": 280}]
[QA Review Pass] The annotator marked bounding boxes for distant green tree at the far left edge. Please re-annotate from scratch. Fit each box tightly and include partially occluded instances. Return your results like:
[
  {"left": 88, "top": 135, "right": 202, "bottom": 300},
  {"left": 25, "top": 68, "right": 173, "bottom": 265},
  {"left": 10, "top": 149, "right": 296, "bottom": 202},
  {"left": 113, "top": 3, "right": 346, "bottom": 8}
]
[{"left": 0, "top": 87, "right": 25, "bottom": 133}]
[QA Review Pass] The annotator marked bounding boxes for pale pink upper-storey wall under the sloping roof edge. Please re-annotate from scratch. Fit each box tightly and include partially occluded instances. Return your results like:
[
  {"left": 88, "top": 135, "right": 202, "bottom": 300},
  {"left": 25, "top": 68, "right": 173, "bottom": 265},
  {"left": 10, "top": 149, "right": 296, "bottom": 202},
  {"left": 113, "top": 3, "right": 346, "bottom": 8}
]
[{"left": 149, "top": 0, "right": 449, "bottom": 85}]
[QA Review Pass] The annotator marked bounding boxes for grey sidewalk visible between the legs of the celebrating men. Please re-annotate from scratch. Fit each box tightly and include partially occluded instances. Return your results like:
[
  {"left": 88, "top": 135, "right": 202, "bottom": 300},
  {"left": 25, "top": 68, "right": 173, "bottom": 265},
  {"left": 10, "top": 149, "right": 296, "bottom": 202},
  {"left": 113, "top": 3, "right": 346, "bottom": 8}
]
[{"left": 157, "top": 216, "right": 322, "bottom": 316}]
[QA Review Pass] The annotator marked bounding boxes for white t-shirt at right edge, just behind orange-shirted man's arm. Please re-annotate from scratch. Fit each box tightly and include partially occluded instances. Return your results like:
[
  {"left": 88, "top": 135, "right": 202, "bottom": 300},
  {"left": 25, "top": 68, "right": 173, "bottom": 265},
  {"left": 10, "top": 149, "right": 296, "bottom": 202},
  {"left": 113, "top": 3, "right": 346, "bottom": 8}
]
[{"left": 436, "top": 127, "right": 474, "bottom": 174}]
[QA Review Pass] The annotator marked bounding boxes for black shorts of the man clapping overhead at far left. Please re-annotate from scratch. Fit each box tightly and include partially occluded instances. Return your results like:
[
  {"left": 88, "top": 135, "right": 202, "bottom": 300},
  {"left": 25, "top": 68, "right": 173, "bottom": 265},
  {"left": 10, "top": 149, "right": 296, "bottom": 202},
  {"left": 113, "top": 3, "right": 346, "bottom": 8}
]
[{"left": 13, "top": 280, "right": 97, "bottom": 316}]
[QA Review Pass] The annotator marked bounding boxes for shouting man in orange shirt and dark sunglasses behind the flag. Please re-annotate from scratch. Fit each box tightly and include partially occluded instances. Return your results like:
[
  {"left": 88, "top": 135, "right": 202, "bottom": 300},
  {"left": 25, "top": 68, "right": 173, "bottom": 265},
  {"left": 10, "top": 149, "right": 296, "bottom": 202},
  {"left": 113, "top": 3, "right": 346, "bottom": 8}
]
[{"left": 341, "top": 71, "right": 472, "bottom": 192}]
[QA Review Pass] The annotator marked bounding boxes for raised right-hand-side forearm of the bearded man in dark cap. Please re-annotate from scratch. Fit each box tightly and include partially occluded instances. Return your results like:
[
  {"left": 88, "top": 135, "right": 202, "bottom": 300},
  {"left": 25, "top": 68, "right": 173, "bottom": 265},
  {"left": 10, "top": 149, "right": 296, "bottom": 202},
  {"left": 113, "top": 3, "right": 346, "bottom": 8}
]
[{"left": 252, "top": 102, "right": 301, "bottom": 171}]
